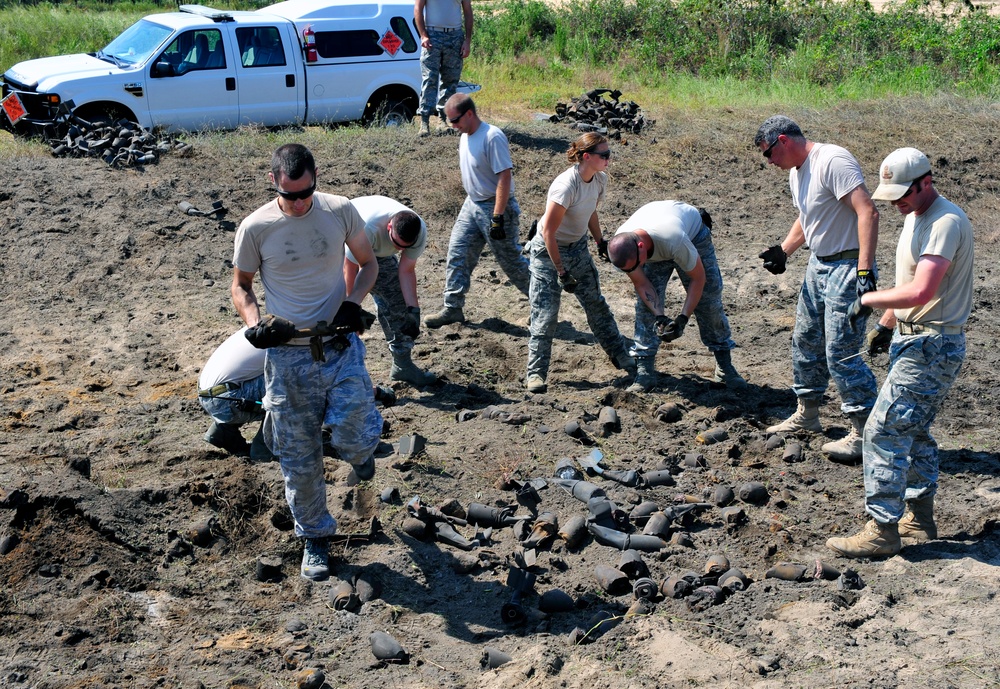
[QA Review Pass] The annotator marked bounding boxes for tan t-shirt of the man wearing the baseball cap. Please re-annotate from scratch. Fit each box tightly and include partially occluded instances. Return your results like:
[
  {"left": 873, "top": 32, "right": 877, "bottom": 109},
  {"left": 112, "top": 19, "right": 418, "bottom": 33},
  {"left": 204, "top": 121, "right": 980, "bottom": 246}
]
[{"left": 895, "top": 196, "right": 973, "bottom": 326}]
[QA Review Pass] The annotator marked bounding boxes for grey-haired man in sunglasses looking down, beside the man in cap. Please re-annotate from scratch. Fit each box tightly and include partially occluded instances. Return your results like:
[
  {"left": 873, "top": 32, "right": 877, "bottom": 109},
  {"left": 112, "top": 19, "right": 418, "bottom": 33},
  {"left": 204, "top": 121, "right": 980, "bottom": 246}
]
[{"left": 754, "top": 115, "right": 878, "bottom": 464}]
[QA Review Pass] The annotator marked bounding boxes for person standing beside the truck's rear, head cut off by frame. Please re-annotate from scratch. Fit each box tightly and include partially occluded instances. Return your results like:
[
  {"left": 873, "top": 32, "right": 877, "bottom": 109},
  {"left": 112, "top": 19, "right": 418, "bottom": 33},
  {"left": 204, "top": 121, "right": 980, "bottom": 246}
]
[{"left": 413, "top": 0, "right": 472, "bottom": 136}]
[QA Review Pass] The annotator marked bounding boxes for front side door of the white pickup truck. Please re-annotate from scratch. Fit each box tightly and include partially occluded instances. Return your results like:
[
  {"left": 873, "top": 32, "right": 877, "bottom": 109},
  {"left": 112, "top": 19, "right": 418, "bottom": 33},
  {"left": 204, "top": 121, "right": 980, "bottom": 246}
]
[{"left": 147, "top": 27, "right": 239, "bottom": 131}]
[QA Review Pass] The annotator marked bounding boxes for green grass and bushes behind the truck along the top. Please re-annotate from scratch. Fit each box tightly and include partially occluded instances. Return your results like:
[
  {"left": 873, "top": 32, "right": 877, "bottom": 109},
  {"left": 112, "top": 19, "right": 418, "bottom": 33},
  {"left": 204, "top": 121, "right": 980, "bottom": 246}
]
[{"left": 0, "top": 0, "right": 1000, "bottom": 98}]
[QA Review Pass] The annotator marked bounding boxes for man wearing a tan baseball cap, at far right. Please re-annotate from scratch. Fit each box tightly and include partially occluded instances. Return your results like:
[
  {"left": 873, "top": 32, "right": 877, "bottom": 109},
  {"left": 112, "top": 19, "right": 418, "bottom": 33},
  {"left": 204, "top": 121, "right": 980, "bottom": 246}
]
[{"left": 827, "top": 148, "right": 973, "bottom": 558}]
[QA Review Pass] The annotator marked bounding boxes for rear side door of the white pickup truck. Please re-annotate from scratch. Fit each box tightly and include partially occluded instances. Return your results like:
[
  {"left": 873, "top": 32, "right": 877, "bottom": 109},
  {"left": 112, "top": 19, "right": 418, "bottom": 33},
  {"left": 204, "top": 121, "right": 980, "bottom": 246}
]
[{"left": 235, "top": 22, "right": 305, "bottom": 127}]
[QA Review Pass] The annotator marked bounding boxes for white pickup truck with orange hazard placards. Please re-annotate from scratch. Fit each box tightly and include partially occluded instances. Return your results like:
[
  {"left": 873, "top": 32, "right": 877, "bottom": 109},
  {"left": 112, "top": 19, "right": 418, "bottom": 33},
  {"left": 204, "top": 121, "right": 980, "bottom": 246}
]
[{"left": 0, "top": 0, "right": 478, "bottom": 134}]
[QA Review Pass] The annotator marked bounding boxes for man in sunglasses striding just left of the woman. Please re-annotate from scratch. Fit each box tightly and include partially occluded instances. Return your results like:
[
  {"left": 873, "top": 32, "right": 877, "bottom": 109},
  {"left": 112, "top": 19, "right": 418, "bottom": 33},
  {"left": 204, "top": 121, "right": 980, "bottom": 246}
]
[{"left": 424, "top": 93, "right": 530, "bottom": 328}]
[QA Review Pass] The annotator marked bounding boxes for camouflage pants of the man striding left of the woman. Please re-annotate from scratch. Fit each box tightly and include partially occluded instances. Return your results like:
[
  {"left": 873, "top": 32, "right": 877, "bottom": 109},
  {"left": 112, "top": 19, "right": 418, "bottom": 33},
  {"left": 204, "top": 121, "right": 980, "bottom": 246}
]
[{"left": 444, "top": 196, "right": 530, "bottom": 309}]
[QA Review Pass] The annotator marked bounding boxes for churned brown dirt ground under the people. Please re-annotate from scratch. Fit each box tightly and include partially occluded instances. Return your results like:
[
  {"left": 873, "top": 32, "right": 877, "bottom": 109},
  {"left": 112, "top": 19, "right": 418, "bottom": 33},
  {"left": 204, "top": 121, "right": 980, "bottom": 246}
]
[{"left": 0, "top": 94, "right": 1000, "bottom": 689}]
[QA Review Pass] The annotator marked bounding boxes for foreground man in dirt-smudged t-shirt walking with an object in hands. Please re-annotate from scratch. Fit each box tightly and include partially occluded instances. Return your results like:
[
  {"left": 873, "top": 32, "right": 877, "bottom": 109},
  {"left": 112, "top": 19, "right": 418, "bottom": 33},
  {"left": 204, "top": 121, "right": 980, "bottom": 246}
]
[{"left": 230, "top": 144, "right": 382, "bottom": 580}]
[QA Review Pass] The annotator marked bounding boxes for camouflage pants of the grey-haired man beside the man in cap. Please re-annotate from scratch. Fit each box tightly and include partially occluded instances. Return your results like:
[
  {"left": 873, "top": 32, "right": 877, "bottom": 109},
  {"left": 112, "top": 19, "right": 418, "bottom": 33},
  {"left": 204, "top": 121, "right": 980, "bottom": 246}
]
[{"left": 792, "top": 254, "right": 877, "bottom": 414}]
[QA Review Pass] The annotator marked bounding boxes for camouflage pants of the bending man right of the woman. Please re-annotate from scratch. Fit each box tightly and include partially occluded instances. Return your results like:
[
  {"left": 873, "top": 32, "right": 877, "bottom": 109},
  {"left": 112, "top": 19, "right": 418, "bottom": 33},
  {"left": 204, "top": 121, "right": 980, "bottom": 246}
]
[{"left": 632, "top": 225, "right": 736, "bottom": 359}]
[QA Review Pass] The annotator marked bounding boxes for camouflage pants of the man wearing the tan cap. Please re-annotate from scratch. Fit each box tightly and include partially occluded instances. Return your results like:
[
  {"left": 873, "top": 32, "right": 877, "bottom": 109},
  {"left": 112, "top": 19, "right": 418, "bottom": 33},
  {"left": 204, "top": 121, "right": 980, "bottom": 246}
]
[{"left": 862, "top": 331, "right": 965, "bottom": 523}]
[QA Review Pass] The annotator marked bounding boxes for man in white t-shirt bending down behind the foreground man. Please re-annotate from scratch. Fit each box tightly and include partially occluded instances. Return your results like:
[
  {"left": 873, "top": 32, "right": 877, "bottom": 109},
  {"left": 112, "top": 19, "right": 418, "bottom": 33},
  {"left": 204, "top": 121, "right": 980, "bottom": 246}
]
[{"left": 344, "top": 196, "right": 437, "bottom": 385}]
